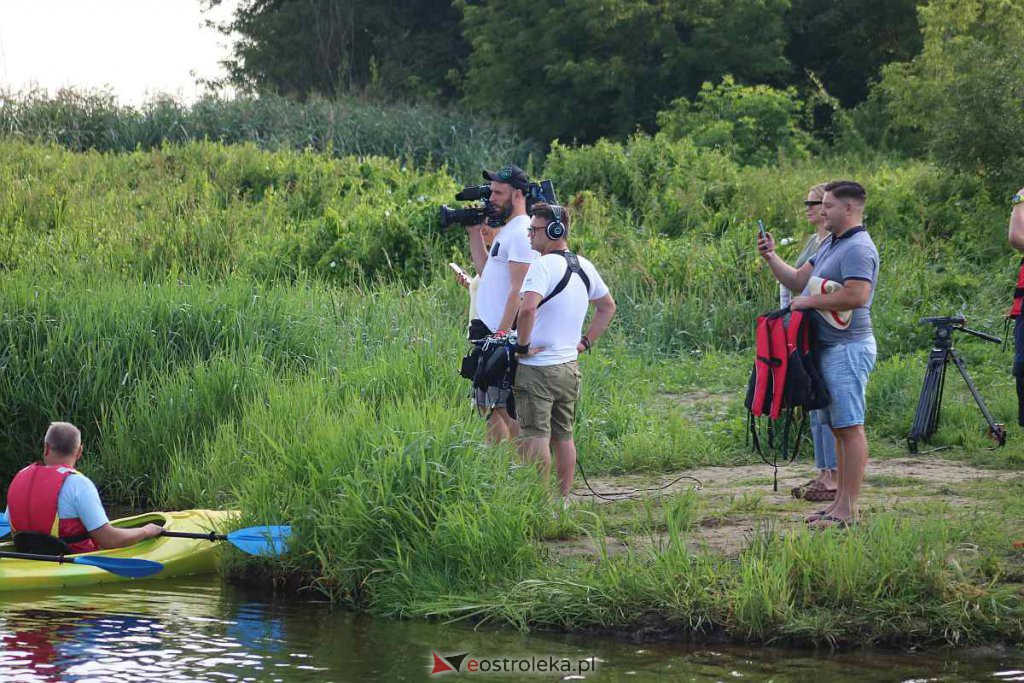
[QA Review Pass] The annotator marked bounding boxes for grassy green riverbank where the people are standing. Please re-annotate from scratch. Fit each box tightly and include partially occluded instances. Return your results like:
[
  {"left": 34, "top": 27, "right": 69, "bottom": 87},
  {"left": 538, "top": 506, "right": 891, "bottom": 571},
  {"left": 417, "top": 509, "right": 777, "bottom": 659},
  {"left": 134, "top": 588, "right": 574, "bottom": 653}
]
[{"left": 0, "top": 138, "right": 1024, "bottom": 644}]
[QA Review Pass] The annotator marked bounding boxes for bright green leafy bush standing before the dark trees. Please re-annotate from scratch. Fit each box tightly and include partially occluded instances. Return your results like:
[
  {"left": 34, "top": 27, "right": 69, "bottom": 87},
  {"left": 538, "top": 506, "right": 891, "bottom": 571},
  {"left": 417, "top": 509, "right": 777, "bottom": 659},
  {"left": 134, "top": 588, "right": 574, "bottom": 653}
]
[{"left": 657, "top": 76, "right": 811, "bottom": 165}]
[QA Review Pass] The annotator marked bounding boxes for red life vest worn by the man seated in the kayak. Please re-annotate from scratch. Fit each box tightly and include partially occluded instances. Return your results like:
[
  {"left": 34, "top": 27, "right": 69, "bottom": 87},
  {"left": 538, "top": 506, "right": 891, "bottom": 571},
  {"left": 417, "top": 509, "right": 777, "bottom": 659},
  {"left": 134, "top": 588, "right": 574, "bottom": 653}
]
[{"left": 7, "top": 464, "right": 99, "bottom": 553}]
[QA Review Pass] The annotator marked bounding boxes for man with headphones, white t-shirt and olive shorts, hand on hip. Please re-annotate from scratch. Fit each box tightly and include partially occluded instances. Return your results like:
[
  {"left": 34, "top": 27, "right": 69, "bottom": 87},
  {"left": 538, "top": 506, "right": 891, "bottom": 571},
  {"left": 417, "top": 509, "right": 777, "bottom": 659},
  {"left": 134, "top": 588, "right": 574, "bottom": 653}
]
[{"left": 515, "top": 203, "right": 615, "bottom": 499}]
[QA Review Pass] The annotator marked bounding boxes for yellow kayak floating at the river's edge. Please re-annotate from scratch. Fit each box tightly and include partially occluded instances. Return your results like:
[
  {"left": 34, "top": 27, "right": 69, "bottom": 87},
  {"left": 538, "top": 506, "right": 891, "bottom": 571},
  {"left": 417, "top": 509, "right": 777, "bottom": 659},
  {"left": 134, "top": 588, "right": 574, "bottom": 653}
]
[{"left": 0, "top": 510, "right": 239, "bottom": 593}]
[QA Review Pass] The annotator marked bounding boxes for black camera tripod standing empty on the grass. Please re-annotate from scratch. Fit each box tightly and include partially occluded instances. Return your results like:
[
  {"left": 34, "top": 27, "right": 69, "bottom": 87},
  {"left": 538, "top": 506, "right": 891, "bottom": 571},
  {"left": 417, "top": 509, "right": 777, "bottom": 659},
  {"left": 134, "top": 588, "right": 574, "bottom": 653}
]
[{"left": 906, "top": 315, "right": 1007, "bottom": 453}]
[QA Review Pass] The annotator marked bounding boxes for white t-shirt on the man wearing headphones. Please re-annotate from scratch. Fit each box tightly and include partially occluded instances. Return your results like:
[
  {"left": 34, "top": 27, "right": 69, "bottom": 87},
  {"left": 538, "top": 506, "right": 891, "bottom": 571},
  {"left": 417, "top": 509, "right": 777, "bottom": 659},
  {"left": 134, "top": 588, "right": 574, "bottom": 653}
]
[{"left": 519, "top": 254, "right": 608, "bottom": 366}]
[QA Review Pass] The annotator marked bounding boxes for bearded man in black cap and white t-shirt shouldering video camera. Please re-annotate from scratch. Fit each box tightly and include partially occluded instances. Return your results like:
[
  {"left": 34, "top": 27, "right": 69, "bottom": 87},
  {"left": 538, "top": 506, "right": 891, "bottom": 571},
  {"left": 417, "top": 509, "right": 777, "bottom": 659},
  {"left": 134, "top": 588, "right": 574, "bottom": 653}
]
[{"left": 466, "top": 164, "right": 537, "bottom": 443}]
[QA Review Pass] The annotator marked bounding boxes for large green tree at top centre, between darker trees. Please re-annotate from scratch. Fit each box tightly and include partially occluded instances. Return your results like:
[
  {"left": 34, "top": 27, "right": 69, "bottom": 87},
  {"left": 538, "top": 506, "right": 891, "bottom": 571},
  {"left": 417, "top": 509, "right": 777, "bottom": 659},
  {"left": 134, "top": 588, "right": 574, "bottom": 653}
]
[{"left": 462, "top": 0, "right": 788, "bottom": 142}]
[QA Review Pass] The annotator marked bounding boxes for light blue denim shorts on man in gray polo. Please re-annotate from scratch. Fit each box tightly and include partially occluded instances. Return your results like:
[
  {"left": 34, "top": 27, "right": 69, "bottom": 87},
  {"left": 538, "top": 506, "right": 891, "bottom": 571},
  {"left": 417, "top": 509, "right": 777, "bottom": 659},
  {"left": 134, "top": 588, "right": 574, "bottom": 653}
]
[{"left": 821, "top": 337, "right": 878, "bottom": 429}]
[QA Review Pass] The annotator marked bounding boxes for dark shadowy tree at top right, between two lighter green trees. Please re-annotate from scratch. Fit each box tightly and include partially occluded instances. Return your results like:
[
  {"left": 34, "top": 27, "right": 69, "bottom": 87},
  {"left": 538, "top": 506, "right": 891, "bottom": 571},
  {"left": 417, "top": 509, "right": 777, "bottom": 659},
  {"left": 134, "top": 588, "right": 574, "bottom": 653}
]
[{"left": 785, "top": 0, "right": 924, "bottom": 106}]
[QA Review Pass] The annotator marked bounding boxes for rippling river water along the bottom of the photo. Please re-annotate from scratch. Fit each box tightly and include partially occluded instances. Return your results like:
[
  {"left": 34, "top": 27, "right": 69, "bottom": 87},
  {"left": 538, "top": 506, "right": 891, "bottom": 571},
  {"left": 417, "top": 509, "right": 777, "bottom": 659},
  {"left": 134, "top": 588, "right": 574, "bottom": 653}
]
[{"left": 0, "top": 578, "right": 1024, "bottom": 683}]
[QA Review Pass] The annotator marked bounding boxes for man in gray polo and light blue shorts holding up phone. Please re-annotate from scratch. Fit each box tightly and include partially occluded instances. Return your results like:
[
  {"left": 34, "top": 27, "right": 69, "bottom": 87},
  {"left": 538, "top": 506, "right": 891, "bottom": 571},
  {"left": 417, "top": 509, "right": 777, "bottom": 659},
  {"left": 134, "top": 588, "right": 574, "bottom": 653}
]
[{"left": 758, "top": 180, "right": 879, "bottom": 528}]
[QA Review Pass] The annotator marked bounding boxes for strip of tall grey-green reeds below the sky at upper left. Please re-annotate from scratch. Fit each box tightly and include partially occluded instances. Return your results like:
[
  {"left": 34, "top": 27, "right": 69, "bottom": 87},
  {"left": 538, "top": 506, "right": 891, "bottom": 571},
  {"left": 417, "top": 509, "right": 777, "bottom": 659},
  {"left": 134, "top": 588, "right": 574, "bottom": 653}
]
[{"left": 0, "top": 89, "right": 538, "bottom": 181}]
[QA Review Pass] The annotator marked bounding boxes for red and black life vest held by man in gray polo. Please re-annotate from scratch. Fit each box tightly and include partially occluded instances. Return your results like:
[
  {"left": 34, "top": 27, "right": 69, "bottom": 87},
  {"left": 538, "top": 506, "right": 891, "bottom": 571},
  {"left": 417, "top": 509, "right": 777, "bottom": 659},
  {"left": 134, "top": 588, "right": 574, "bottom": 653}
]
[{"left": 743, "top": 308, "right": 828, "bottom": 490}]
